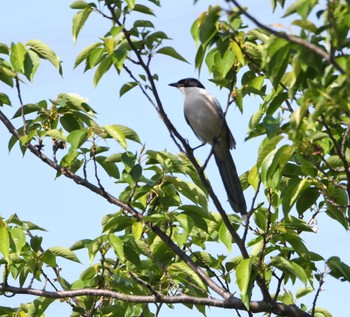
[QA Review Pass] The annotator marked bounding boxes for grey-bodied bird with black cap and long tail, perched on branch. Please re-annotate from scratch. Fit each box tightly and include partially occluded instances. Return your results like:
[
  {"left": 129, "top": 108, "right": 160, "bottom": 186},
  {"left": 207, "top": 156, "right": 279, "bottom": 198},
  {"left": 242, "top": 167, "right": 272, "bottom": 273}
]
[{"left": 169, "top": 78, "right": 247, "bottom": 218}]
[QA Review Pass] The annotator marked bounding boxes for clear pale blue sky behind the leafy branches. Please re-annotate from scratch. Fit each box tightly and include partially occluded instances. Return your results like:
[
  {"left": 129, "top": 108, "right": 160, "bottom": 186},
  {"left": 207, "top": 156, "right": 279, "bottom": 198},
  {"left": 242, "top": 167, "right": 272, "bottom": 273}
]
[{"left": 0, "top": 0, "right": 350, "bottom": 317}]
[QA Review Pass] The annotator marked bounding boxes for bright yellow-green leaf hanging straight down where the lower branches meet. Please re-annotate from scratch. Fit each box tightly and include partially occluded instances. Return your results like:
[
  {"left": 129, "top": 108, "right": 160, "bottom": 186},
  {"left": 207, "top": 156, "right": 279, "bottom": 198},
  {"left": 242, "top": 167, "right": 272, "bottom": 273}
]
[{"left": 236, "top": 259, "right": 252, "bottom": 310}]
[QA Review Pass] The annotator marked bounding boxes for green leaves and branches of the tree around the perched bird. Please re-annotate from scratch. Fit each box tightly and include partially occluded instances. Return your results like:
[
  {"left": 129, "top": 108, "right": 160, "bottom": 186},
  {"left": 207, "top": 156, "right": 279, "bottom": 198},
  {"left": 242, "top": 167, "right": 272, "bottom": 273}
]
[{"left": 0, "top": 0, "right": 350, "bottom": 317}]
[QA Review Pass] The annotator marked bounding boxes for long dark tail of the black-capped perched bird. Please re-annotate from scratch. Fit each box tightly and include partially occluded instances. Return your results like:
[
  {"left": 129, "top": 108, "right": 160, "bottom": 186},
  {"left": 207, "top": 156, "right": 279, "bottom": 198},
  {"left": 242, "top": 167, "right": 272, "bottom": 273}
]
[{"left": 214, "top": 148, "right": 247, "bottom": 216}]
